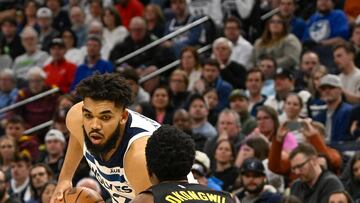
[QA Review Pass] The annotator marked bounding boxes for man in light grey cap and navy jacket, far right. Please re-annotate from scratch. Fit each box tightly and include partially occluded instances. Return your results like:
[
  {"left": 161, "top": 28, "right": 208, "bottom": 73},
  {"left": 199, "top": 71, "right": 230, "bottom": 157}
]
[{"left": 314, "top": 74, "right": 352, "bottom": 143}]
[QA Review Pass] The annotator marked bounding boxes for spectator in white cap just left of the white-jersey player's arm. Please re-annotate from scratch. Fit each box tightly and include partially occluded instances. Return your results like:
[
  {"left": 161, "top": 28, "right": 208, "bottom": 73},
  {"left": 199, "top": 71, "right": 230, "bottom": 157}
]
[{"left": 41, "top": 129, "right": 66, "bottom": 179}]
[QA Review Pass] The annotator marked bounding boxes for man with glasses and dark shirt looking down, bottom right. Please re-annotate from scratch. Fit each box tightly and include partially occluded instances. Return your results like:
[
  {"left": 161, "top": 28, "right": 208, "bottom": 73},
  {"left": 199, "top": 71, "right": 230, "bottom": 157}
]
[{"left": 290, "top": 144, "right": 344, "bottom": 203}]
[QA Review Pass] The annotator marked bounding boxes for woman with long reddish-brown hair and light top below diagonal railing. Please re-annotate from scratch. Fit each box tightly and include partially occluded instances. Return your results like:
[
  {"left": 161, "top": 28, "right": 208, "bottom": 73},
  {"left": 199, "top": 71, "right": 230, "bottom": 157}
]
[{"left": 179, "top": 47, "right": 201, "bottom": 91}]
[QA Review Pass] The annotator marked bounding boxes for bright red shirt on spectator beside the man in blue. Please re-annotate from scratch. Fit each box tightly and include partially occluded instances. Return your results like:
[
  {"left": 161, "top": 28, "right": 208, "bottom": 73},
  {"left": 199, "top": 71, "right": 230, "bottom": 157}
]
[{"left": 44, "top": 60, "right": 76, "bottom": 93}]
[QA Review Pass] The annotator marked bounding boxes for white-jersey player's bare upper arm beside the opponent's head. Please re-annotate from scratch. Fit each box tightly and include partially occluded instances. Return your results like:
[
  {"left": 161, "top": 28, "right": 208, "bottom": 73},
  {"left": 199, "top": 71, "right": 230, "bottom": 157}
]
[{"left": 124, "top": 136, "right": 151, "bottom": 194}]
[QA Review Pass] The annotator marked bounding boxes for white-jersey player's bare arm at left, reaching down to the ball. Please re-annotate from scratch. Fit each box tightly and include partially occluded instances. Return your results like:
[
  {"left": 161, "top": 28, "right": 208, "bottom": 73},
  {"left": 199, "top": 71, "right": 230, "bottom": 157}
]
[{"left": 50, "top": 103, "right": 84, "bottom": 203}]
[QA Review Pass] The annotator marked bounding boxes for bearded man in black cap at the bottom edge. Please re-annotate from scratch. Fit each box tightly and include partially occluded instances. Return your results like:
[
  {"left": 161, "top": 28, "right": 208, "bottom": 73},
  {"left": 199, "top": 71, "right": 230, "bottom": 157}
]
[{"left": 236, "top": 158, "right": 282, "bottom": 203}]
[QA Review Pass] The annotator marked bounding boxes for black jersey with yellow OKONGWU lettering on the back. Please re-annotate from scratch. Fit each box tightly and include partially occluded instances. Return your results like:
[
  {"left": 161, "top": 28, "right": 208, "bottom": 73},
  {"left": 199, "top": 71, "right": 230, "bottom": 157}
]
[{"left": 142, "top": 182, "right": 234, "bottom": 203}]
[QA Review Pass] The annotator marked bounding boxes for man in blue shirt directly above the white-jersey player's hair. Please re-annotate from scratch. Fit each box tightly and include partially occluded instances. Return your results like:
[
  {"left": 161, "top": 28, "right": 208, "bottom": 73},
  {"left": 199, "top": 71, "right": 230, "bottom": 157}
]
[{"left": 70, "top": 35, "right": 114, "bottom": 90}]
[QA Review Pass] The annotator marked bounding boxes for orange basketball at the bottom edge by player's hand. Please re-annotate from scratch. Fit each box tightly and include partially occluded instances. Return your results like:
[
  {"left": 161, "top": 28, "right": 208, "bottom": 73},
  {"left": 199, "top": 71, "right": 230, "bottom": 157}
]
[{"left": 56, "top": 187, "right": 105, "bottom": 203}]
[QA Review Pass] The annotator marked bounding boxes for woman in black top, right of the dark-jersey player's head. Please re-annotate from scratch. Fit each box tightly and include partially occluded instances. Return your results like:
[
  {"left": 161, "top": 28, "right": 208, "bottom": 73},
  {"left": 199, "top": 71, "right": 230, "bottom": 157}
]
[{"left": 213, "top": 139, "right": 239, "bottom": 192}]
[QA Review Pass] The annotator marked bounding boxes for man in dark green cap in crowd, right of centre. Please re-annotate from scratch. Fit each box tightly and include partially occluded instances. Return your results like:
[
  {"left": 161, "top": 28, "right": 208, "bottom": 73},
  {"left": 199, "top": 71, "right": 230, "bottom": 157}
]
[{"left": 229, "top": 89, "right": 257, "bottom": 135}]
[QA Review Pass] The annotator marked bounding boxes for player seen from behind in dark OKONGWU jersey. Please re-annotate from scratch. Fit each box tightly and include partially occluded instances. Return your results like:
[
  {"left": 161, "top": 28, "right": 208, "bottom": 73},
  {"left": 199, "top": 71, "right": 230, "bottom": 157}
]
[{"left": 132, "top": 125, "right": 233, "bottom": 203}]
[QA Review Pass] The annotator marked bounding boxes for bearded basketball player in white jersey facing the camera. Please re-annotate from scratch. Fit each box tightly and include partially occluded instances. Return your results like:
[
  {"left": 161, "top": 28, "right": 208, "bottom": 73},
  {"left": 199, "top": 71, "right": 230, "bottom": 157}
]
[{"left": 52, "top": 74, "right": 160, "bottom": 202}]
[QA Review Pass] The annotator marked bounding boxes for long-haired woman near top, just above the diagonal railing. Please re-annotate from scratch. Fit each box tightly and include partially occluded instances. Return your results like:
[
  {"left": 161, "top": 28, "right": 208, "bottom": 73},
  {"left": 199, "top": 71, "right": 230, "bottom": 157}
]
[{"left": 144, "top": 3, "right": 165, "bottom": 38}]
